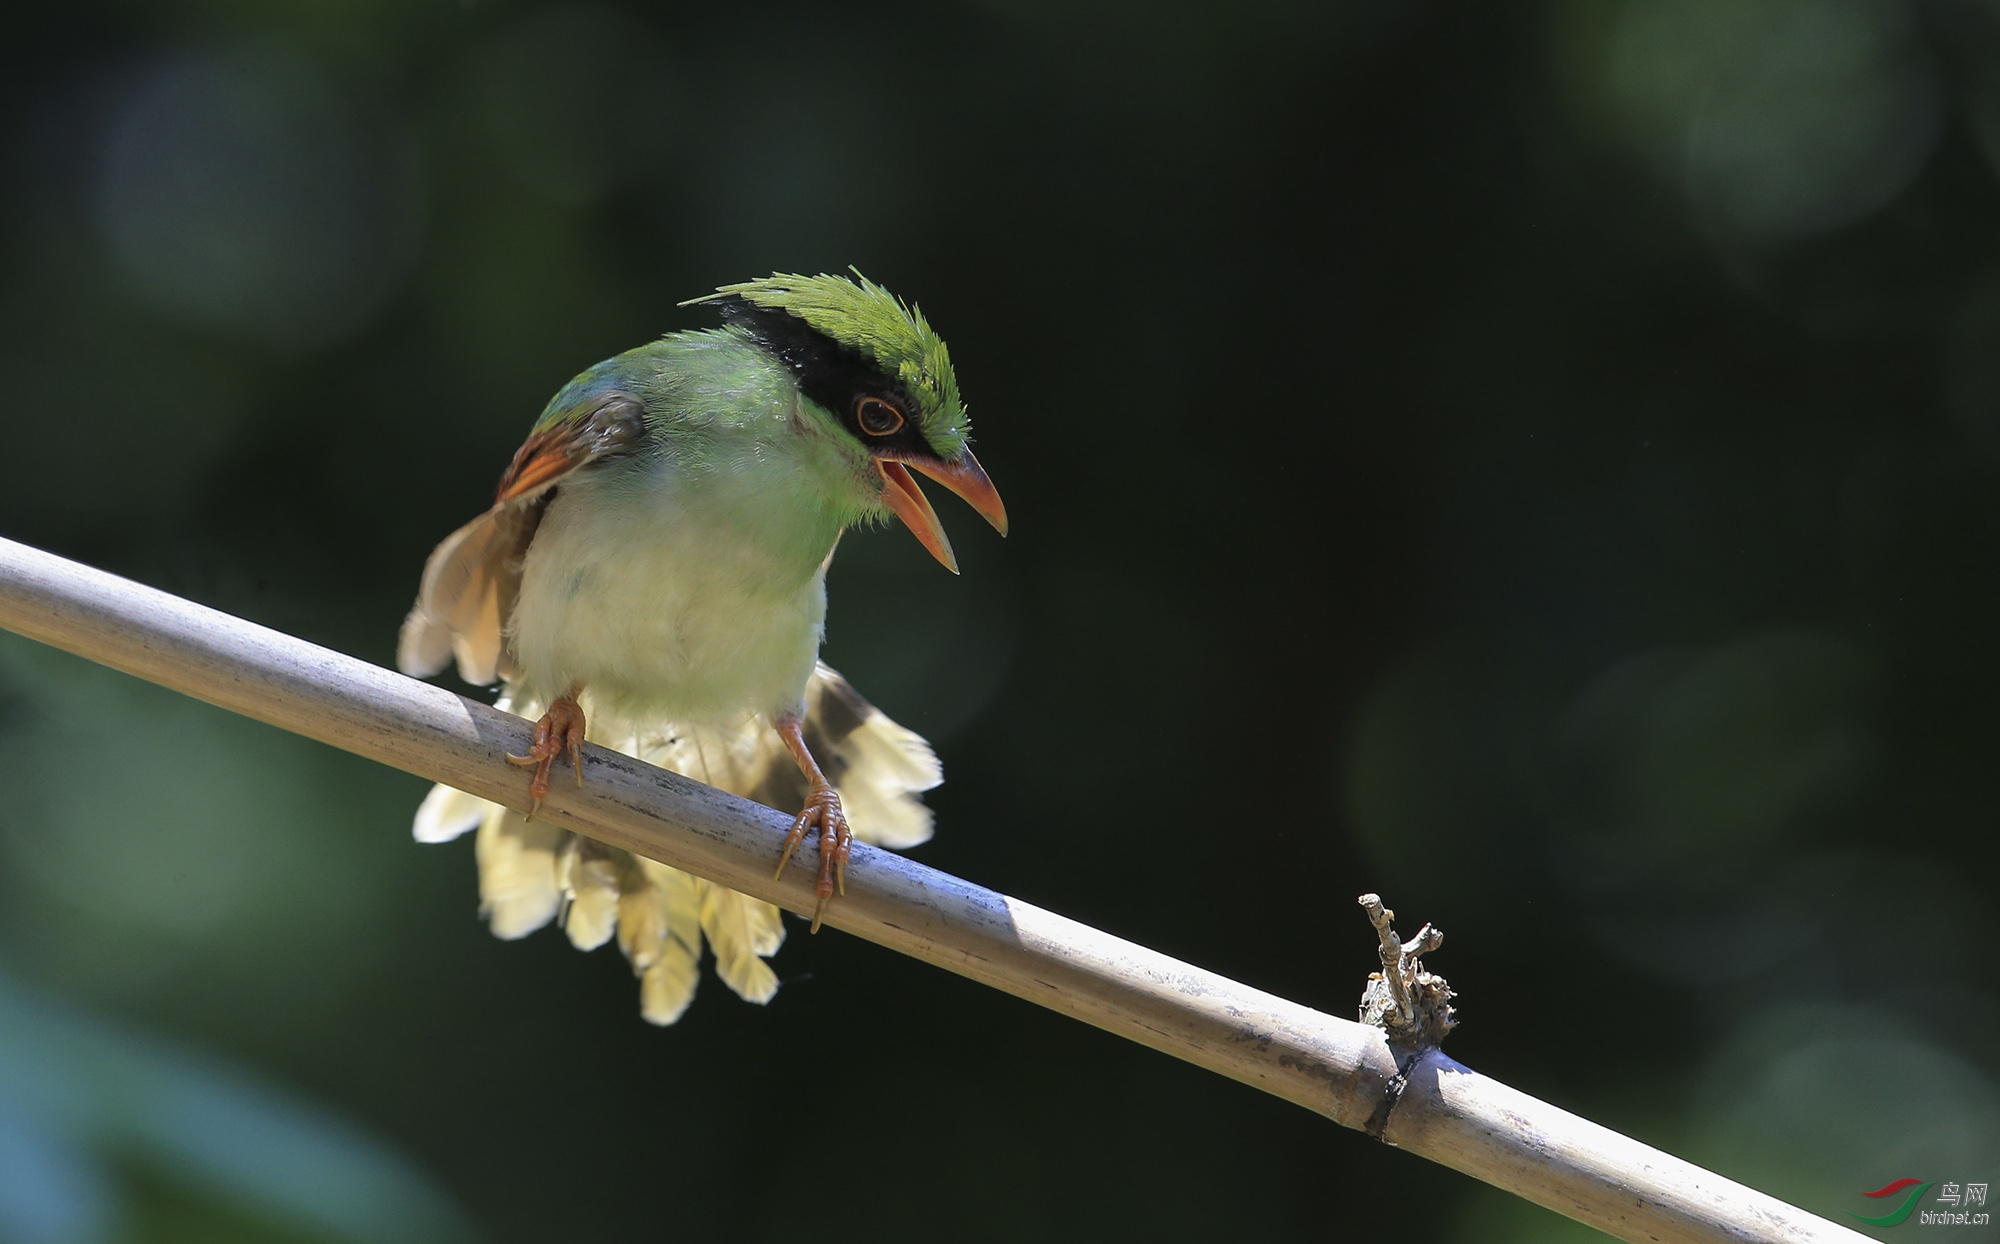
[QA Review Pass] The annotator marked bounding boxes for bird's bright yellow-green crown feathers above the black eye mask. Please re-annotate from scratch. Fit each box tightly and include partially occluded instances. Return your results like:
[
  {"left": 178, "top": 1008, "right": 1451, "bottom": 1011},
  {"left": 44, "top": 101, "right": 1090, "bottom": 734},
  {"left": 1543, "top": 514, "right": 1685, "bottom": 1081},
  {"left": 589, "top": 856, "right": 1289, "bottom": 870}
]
[{"left": 682, "top": 268, "right": 972, "bottom": 458}]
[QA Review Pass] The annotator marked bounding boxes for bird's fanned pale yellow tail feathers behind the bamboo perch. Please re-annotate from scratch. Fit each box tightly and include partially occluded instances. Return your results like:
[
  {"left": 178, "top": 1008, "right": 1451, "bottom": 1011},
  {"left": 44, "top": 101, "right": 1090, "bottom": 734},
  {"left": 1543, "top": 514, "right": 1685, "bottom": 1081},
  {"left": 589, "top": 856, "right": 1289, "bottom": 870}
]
[{"left": 412, "top": 664, "right": 944, "bottom": 1024}]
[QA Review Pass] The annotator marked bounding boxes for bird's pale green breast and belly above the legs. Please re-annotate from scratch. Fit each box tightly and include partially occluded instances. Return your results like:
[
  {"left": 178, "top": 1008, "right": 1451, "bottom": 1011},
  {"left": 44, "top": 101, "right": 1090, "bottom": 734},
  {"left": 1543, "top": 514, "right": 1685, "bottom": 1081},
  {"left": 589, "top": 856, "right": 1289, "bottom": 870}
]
[{"left": 510, "top": 332, "right": 852, "bottom": 720}]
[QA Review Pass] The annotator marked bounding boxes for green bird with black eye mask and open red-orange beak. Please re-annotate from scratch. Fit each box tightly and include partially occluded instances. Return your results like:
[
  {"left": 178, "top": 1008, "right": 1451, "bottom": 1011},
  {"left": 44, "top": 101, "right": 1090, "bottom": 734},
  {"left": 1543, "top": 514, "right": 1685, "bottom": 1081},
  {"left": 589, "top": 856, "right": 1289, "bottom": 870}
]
[{"left": 396, "top": 272, "right": 1006, "bottom": 1024}]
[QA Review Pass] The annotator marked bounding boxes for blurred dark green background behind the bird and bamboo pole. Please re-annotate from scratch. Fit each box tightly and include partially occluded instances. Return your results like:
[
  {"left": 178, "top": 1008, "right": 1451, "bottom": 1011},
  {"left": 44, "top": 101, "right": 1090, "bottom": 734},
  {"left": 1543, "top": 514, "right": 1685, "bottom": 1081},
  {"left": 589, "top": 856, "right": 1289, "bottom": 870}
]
[{"left": 0, "top": 0, "right": 2000, "bottom": 1244}]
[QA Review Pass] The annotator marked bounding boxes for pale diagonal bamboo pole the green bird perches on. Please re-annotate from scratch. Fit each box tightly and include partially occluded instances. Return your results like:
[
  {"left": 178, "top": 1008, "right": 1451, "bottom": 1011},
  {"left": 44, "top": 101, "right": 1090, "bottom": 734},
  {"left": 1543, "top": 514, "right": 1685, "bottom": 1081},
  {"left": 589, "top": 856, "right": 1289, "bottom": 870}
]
[{"left": 0, "top": 540, "right": 1864, "bottom": 1244}]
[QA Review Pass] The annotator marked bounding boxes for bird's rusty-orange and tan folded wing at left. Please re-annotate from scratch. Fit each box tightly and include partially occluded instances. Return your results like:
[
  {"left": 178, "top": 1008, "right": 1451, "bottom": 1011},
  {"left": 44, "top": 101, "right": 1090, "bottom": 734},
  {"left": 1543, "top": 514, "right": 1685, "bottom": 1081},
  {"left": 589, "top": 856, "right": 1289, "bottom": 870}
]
[{"left": 396, "top": 394, "right": 646, "bottom": 686}]
